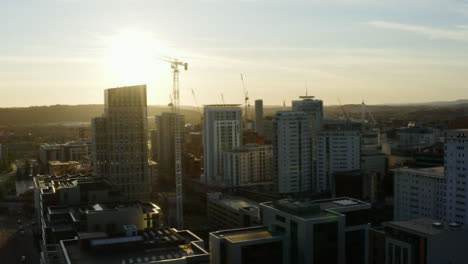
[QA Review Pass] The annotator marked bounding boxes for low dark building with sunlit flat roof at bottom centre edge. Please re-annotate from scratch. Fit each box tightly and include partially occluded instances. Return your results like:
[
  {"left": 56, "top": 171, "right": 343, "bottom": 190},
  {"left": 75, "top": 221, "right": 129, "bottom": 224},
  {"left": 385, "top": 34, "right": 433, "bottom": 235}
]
[{"left": 210, "top": 226, "right": 288, "bottom": 264}]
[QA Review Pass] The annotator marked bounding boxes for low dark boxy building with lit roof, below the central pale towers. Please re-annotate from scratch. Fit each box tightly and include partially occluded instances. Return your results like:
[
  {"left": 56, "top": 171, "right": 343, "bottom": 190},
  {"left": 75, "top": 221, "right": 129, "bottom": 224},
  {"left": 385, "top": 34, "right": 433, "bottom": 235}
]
[{"left": 206, "top": 192, "right": 261, "bottom": 230}]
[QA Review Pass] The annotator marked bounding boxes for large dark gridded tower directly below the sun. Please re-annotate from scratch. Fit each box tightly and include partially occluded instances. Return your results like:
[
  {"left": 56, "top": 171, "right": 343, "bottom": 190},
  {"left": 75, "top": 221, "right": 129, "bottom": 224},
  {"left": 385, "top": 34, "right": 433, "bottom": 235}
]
[{"left": 92, "top": 85, "right": 151, "bottom": 200}]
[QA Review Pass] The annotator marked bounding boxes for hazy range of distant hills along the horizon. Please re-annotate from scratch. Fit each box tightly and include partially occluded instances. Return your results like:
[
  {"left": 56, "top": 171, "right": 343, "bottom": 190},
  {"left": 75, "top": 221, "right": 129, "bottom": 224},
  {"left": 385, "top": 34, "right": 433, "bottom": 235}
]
[{"left": 0, "top": 100, "right": 468, "bottom": 126}]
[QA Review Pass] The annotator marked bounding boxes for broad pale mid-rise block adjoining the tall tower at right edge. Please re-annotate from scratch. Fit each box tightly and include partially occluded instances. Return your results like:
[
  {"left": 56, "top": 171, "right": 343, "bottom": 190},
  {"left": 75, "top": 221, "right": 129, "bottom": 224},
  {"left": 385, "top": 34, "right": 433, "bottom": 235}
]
[{"left": 393, "top": 167, "right": 447, "bottom": 221}]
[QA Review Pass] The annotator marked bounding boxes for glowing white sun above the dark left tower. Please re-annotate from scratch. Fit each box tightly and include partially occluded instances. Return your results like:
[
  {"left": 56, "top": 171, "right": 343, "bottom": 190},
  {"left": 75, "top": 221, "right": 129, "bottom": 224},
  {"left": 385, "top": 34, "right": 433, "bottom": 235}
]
[{"left": 106, "top": 30, "right": 170, "bottom": 86}]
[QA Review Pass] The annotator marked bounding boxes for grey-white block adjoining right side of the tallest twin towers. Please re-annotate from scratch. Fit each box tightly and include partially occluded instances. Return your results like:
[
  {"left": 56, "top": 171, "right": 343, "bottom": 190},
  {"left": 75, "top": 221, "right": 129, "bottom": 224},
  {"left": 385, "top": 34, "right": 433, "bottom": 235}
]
[{"left": 314, "top": 130, "right": 361, "bottom": 192}]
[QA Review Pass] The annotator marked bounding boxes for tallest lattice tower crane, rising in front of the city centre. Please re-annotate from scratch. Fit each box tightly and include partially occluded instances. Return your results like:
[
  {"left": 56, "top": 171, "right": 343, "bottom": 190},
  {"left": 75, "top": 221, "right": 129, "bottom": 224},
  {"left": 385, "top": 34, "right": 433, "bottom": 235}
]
[{"left": 164, "top": 59, "right": 188, "bottom": 230}]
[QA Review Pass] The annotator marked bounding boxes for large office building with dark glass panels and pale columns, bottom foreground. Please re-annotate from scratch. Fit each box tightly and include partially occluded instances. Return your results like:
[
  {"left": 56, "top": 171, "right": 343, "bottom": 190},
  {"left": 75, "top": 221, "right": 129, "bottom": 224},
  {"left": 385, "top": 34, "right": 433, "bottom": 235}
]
[{"left": 260, "top": 198, "right": 371, "bottom": 264}]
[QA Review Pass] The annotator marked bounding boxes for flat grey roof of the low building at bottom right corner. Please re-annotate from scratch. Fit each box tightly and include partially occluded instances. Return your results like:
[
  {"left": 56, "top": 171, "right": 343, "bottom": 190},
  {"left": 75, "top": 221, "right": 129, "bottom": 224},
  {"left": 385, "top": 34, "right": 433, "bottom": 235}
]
[{"left": 383, "top": 217, "right": 464, "bottom": 236}]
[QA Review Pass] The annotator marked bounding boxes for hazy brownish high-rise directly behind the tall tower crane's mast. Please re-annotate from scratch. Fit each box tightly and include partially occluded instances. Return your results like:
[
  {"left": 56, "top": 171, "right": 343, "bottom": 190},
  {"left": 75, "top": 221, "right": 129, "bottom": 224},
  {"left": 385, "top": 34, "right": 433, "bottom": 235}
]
[{"left": 154, "top": 113, "right": 185, "bottom": 182}]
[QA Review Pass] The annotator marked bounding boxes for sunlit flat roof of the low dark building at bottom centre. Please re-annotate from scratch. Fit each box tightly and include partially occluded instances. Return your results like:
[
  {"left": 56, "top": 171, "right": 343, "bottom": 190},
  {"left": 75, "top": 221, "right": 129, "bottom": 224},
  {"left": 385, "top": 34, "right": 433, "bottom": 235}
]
[{"left": 212, "top": 227, "right": 281, "bottom": 243}]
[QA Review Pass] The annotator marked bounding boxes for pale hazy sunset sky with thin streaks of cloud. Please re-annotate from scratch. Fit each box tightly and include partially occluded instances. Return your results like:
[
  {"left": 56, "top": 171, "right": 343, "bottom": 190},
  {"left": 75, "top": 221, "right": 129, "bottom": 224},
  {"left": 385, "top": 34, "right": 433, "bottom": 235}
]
[{"left": 0, "top": 0, "right": 468, "bottom": 107}]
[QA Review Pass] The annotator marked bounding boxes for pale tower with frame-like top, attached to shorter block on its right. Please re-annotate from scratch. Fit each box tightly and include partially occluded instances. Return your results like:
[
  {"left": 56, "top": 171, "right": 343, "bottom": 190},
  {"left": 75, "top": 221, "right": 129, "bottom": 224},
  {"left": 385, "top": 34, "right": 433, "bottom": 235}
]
[{"left": 203, "top": 104, "right": 242, "bottom": 186}]
